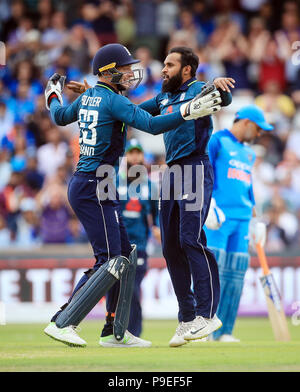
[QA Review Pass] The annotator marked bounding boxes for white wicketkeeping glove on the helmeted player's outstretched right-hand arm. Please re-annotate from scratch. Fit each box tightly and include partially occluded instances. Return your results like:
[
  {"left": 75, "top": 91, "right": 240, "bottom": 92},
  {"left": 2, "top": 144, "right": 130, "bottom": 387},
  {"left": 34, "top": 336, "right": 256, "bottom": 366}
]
[{"left": 180, "top": 83, "right": 222, "bottom": 120}]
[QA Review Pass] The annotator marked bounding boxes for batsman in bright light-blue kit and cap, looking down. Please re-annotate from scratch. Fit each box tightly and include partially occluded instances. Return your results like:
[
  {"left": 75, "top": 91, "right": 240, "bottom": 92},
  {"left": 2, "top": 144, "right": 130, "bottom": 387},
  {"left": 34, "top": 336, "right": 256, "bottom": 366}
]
[{"left": 205, "top": 105, "right": 273, "bottom": 342}]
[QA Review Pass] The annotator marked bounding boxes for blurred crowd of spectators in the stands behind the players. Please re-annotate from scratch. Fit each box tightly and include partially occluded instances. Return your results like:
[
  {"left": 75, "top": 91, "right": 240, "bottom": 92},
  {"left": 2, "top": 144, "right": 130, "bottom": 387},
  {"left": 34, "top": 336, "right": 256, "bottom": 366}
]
[{"left": 0, "top": 0, "right": 300, "bottom": 252}]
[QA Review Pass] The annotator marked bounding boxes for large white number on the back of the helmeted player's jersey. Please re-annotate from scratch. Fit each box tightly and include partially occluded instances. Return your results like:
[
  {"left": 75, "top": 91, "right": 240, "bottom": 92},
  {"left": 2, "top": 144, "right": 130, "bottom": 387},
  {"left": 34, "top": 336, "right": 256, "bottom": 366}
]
[{"left": 79, "top": 109, "right": 98, "bottom": 146}]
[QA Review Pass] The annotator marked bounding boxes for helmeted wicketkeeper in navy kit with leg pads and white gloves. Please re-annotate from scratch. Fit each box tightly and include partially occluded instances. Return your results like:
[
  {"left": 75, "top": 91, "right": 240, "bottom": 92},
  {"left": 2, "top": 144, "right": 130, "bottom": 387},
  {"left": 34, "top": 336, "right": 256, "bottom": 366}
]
[{"left": 44, "top": 44, "right": 221, "bottom": 347}]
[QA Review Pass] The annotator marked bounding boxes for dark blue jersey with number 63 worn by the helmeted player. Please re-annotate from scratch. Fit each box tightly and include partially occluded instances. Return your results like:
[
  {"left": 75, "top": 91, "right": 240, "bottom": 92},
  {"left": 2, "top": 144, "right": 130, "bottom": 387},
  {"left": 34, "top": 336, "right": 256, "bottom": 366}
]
[{"left": 50, "top": 82, "right": 186, "bottom": 172}]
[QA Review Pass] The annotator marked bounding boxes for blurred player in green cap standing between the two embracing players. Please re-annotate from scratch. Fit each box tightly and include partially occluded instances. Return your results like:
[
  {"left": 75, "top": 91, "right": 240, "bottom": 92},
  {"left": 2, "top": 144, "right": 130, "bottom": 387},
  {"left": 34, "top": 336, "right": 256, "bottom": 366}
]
[{"left": 118, "top": 139, "right": 160, "bottom": 336}]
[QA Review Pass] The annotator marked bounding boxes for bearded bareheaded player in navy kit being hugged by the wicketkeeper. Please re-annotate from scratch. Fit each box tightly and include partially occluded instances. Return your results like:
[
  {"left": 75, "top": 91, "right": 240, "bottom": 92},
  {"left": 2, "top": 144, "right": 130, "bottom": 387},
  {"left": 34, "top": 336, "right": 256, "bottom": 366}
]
[{"left": 70, "top": 47, "right": 235, "bottom": 347}]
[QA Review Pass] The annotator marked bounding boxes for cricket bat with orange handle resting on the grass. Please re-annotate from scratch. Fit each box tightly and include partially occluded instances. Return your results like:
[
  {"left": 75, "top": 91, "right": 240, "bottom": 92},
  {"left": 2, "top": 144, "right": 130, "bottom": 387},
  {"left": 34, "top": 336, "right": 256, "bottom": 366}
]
[{"left": 256, "top": 244, "right": 291, "bottom": 341}]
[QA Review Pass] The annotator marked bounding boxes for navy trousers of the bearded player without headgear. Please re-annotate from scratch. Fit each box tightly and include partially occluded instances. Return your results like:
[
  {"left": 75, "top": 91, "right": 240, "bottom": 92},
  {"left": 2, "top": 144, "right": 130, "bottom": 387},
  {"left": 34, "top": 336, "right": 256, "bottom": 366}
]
[{"left": 160, "top": 155, "right": 220, "bottom": 322}]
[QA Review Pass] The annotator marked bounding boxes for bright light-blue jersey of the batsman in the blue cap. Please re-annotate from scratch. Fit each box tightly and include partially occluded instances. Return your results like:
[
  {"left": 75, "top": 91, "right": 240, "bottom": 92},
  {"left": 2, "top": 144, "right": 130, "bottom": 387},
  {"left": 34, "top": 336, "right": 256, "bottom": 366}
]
[{"left": 208, "top": 129, "right": 255, "bottom": 220}]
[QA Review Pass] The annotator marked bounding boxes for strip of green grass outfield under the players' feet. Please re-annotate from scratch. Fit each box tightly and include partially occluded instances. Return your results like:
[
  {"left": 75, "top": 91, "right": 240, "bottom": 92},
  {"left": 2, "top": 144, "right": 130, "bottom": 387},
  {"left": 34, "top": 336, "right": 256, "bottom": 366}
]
[{"left": 0, "top": 318, "right": 300, "bottom": 372}]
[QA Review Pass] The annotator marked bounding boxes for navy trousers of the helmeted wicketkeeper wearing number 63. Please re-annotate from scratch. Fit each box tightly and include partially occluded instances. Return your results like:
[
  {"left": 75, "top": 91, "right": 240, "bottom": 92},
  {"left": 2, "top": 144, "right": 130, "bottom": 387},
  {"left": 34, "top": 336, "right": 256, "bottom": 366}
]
[{"left": 52, "top": 172, "right": 131, "bottom": 321}]
